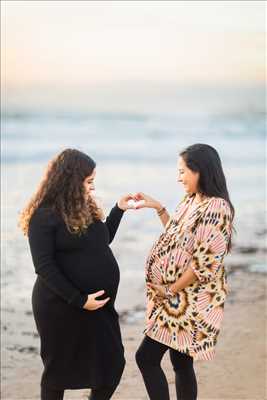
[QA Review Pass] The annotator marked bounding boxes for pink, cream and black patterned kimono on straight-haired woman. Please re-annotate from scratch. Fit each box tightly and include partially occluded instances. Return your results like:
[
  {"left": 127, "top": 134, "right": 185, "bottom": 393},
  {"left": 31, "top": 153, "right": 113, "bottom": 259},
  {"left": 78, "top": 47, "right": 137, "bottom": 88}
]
[{"left": 144, "top": 194, "right": 231, "bottom": 360}]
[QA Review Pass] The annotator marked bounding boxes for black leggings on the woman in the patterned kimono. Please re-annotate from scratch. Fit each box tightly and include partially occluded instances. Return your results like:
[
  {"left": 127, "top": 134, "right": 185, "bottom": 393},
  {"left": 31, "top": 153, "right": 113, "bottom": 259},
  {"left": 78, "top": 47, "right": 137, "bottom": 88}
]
[{"left": 135, "top": 336, "right": 197, "bottom": 400}]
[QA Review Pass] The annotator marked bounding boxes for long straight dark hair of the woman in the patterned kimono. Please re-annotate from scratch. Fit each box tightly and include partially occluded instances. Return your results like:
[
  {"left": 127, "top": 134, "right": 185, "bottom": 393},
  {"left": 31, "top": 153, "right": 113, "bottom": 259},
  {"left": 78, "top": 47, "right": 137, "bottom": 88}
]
[{"left": 180, "top": 143, "right": 235, "bottom": 251}]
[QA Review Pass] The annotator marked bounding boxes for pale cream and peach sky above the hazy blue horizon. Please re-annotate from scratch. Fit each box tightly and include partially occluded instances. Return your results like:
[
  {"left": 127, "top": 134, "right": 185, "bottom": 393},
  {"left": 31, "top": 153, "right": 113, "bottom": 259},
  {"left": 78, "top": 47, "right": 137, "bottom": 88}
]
[{"left": 1, "top": 0, "right": 265, "bottom": 88}]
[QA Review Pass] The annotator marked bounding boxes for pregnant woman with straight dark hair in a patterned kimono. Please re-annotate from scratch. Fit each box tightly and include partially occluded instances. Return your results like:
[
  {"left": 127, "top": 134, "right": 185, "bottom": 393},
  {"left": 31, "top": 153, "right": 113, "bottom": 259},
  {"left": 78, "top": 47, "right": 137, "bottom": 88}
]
[{"left": 135, "top": 144, "right": 234, "bottom": 400}]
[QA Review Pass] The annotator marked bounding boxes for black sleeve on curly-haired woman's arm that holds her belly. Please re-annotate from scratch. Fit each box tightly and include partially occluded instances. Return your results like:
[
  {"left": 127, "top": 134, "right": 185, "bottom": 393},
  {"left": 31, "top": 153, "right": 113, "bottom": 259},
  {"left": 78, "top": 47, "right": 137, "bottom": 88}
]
[{"left": 28, "top": 208, "right": 87, "bottom": 308}]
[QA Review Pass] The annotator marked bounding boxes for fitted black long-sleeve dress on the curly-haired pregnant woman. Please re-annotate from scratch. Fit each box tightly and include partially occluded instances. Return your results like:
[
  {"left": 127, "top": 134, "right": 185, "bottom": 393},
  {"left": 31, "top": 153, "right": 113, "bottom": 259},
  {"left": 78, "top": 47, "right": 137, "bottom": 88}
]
[{"left": 29, "top": 205, "right": 125, "bottom": 389}]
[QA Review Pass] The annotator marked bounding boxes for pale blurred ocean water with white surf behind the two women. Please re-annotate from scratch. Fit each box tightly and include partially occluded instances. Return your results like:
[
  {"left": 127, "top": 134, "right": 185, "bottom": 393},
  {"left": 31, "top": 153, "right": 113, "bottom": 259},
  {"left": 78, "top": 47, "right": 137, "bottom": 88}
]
[{"left": 1, "top": 110, "right": 266, "bottom": 310}]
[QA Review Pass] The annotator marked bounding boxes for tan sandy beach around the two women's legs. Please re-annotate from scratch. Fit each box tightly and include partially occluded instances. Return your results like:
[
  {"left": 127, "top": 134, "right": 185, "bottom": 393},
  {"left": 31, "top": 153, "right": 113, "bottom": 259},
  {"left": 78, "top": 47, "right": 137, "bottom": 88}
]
[{"left": 1, "top": 268, "right": 267, "bottom": 400}]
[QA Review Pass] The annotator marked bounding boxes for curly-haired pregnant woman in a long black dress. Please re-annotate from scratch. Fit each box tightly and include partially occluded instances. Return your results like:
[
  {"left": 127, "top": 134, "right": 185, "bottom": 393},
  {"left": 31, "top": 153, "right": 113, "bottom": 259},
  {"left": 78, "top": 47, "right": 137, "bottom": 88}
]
[{"left": 20, "top": 149, "right": 135, "bottom": 400}]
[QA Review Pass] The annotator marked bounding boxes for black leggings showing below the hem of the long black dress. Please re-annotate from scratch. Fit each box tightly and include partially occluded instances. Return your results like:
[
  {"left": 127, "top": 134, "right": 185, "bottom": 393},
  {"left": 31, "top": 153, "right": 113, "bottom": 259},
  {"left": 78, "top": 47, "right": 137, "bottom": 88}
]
[{"left": 41, "top": 385, "right": 117, "bottom": 400}]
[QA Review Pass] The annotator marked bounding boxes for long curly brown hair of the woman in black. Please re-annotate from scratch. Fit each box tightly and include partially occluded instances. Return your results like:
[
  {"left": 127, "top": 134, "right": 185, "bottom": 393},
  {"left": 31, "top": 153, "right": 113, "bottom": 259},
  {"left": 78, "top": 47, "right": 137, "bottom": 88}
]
[{"left": 19, "top": 149, "right": 103, "bottom": 235}]
